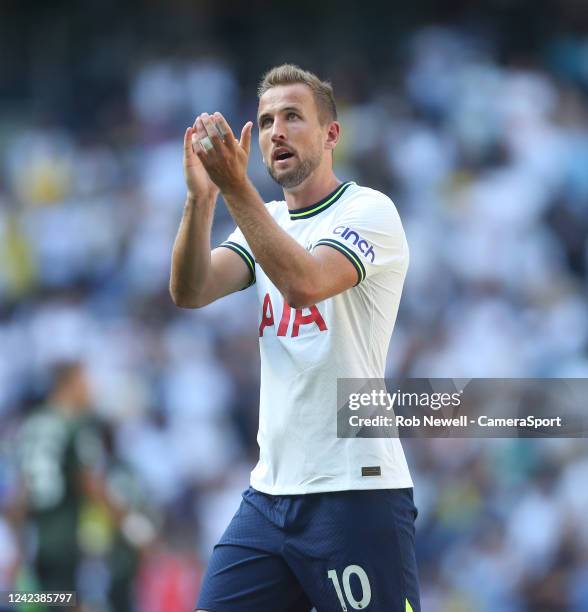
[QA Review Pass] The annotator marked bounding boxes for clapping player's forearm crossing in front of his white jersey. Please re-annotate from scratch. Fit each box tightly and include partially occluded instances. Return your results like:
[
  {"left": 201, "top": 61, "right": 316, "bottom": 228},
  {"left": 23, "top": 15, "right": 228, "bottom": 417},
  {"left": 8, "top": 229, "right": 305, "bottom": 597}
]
[{"left": 223, "top": 180, "right": 320, "bottom": 307}]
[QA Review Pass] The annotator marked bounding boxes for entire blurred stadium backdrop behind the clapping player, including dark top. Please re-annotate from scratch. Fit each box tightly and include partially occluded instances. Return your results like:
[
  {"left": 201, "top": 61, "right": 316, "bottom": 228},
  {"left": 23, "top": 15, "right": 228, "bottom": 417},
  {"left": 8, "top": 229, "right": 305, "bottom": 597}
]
[{"left": 0, "top": 0, "right": 588, "bottom": 612}]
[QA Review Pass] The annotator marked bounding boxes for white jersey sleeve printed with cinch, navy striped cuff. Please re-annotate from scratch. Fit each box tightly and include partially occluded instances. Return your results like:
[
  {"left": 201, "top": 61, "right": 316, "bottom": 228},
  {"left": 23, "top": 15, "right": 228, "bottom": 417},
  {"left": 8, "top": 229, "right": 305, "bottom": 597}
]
[{"left": 314, "top": 192, "right": 409, "bottom": 284}]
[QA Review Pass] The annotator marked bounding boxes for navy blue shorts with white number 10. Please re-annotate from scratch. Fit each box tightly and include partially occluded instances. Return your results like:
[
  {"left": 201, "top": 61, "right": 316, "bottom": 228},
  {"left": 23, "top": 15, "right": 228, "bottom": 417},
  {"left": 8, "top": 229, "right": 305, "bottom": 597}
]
[{"left": 197, "top": 487, "right": 420, "bottom": 612}]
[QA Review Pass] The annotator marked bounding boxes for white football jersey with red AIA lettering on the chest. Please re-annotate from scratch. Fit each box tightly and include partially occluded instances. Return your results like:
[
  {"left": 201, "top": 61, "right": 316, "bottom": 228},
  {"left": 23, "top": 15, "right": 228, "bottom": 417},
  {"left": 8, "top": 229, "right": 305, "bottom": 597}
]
[{"left": 222, "top": 181, "right": 412, "bottom": 495}]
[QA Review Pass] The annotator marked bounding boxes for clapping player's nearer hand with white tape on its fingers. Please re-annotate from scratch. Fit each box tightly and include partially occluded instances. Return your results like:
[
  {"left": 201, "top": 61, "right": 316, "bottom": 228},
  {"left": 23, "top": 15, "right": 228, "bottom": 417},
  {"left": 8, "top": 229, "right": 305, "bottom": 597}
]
[{"left": 194, "top": 113, "right": 253, "bottom": 194}]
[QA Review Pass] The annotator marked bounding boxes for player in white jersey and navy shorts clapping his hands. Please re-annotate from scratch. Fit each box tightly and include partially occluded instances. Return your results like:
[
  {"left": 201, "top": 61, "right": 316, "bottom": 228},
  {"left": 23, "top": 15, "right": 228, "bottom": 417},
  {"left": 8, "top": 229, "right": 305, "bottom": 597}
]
[{"left": 170, "top": 64, "right": 420, "bottom": 612}]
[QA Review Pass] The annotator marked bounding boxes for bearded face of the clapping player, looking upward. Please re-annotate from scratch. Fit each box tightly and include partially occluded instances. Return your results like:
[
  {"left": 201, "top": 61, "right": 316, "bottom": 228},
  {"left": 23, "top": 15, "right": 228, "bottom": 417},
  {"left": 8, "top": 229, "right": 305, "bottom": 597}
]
[{"left": 257, "top": 83, "right": 327, "bottom": 189}]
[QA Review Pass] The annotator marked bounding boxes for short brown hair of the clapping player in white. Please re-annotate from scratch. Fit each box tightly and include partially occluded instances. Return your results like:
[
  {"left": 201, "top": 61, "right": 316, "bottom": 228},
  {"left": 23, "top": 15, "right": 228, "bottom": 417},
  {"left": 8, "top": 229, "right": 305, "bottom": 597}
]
[{"left": 257, "top": 64, "right": 337, "bottom": 125}]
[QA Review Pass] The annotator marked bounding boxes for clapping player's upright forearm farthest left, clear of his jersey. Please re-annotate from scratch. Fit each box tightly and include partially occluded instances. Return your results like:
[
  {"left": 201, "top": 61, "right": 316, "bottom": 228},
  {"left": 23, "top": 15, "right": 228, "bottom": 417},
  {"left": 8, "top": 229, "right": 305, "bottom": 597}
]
[{"left": 169, "top": 197, "right": 214, "bottom": 307}]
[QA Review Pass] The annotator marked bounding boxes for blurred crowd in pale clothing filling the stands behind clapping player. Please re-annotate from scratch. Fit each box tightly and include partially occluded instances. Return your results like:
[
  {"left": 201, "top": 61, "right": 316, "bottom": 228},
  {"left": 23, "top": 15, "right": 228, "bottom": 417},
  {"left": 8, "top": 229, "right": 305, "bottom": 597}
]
[{"left": 0, "top": 10, "right": 588, "bottom": 612}]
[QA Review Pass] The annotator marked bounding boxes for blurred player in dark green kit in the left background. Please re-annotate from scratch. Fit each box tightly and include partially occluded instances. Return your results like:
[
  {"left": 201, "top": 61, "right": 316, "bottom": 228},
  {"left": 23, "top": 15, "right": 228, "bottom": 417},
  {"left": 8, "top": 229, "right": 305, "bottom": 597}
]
[{"left": 18, "top": 362, "right": 104, "bottom": 590}]
